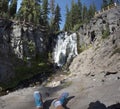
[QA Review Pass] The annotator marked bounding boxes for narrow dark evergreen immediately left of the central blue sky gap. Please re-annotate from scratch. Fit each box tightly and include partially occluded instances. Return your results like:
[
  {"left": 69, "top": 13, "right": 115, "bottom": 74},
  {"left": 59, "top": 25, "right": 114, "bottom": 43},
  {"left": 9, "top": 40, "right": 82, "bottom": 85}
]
[{"left": 54, "top": 4, "right": 61, "bottom": 32}]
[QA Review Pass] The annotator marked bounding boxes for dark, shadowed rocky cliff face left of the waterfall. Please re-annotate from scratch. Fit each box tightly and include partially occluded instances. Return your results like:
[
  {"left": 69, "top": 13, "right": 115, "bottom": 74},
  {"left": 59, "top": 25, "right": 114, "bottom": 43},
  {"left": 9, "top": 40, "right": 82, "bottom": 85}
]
[{"left": 0, "top": 19, "right": 46, "bottom": 82}]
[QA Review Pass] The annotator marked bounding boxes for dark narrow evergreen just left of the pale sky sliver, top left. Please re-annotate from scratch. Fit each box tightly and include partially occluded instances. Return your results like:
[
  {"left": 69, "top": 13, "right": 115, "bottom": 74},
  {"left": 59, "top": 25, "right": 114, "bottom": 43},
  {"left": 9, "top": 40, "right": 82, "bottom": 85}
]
[{"left": 9, "top": 0, "right": 17, "bottom": 17}]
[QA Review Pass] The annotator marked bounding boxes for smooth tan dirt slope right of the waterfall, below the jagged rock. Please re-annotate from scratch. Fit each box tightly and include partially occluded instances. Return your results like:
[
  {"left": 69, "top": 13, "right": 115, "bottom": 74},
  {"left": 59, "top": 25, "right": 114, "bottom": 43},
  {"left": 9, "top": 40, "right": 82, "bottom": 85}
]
[{"left": 70, "top": 30, "right": 120, "bottom": 75}]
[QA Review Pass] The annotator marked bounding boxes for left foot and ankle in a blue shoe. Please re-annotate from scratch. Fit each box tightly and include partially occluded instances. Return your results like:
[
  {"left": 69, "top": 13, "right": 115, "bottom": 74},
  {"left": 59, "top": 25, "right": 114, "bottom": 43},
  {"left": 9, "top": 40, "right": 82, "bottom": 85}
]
[{"left": 34, "top": 91, "right": 43, "bottom": 109}]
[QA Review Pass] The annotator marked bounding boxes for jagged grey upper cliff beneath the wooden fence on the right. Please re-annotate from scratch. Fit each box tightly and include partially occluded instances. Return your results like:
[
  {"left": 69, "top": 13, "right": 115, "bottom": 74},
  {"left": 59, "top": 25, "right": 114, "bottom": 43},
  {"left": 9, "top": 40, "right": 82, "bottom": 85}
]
[{"left": 78, "top": 6, "right": 120, "bottom": 47}]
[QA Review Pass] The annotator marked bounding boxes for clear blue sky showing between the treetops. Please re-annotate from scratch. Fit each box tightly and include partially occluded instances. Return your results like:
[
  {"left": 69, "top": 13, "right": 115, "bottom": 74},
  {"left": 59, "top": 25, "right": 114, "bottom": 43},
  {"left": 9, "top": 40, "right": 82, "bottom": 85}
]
[{"left": 18, "top": 0, "right": 103, "bottom": 30}]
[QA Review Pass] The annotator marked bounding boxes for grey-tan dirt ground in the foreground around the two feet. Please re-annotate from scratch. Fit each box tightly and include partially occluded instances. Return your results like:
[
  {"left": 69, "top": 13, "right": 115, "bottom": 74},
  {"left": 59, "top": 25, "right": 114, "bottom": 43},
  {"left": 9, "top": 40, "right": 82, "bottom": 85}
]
[{"left": 0, "top": 70, "right": 120, "bottom": 109}]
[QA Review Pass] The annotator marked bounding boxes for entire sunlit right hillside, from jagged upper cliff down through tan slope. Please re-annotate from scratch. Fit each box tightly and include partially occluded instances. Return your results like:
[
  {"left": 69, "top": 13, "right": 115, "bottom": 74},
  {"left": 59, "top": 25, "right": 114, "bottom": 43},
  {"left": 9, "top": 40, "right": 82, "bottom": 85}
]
[{"left": 69, "top": 7, "right": 120, "bottom": 84}]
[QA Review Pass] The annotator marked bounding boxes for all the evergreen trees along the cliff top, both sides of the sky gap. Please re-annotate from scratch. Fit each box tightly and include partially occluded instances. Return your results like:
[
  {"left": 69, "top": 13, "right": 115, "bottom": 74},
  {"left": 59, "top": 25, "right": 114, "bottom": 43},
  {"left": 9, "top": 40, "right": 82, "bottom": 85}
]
[{"left": 0, "top": 0, "right": 97, "bottom": 33}]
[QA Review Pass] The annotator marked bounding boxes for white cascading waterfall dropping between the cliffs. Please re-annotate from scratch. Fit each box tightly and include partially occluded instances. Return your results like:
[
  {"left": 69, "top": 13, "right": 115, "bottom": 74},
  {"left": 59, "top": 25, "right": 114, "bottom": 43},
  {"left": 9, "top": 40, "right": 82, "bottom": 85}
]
[{"left": 53, "top": 32, "right": 78, "bottom": 67}]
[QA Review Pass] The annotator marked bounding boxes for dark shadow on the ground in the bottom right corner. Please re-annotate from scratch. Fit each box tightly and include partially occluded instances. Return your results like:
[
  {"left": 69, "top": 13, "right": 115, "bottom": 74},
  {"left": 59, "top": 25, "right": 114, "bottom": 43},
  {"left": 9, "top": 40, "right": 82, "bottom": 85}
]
[{"left": 88, "top": 101, "right": 120, "bottom": 109}]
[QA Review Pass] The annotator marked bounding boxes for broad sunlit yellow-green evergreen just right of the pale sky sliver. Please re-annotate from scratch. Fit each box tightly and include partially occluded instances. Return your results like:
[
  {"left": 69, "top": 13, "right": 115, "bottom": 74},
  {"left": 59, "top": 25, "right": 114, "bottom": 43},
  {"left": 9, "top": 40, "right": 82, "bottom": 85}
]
[{"left": 18, "top": 0, "right": 40, "bottom": 24}]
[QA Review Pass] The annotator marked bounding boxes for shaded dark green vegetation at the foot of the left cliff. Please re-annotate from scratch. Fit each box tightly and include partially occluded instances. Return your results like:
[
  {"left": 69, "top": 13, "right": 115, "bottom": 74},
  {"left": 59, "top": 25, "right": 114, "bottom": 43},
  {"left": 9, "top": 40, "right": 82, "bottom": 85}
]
[{"left": 0, "top": 56, "right": 52, "bottom": 90}]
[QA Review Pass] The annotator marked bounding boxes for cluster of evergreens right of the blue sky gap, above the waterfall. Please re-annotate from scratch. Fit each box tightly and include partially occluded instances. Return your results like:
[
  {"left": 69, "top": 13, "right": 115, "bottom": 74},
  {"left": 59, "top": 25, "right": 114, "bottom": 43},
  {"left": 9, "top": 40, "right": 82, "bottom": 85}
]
[{"left": 64, "top": 0, "right": 96, "bottom": 31}]
